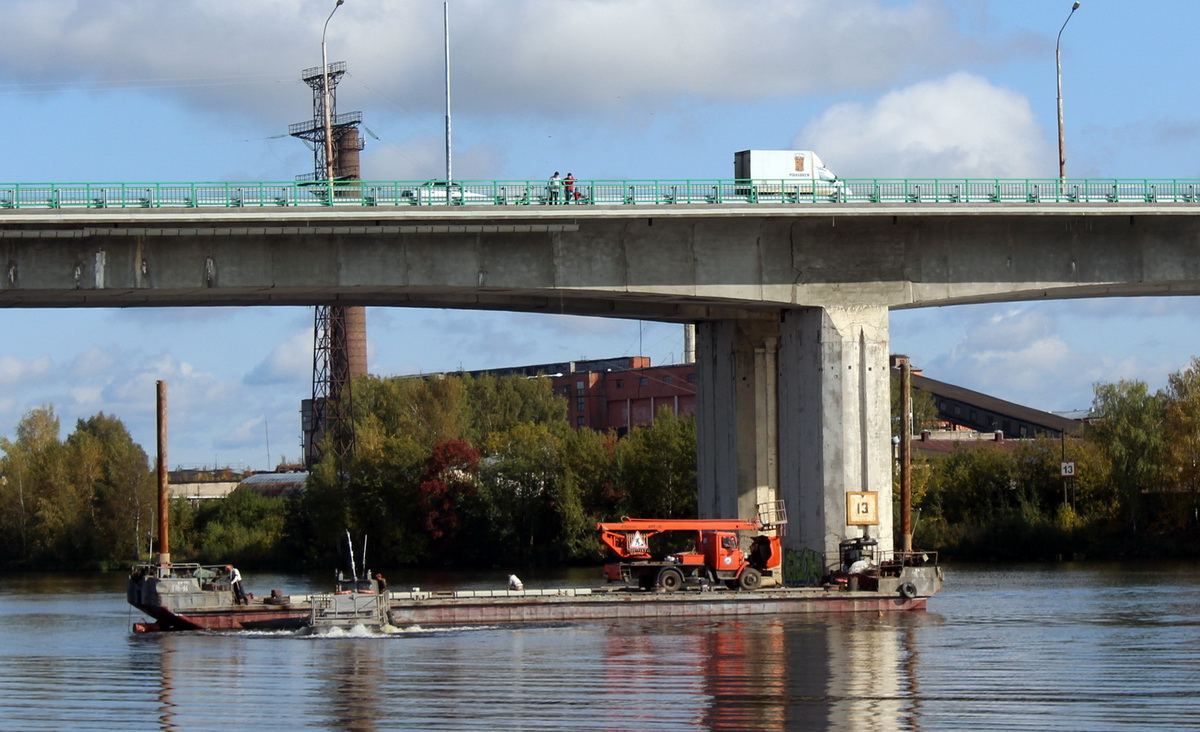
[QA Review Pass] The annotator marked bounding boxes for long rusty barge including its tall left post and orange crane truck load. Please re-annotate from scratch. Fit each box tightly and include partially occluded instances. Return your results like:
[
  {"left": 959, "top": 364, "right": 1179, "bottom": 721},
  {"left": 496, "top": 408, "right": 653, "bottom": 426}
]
[{"left": 126, "top": 382, "right": 943, "bottom": 632}]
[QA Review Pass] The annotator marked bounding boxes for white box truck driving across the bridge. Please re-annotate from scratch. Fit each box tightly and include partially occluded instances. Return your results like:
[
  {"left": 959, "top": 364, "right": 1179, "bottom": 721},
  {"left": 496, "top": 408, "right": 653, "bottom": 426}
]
[{"left": 733, "top": 150, "right": 842, "bottom": 200}]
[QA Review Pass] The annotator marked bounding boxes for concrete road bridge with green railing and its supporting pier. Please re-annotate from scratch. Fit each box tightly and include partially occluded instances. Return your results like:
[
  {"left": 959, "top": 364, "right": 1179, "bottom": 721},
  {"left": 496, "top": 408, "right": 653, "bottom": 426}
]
[{"left": 0, "top": 175, "right": 1200, "bottom": 552}]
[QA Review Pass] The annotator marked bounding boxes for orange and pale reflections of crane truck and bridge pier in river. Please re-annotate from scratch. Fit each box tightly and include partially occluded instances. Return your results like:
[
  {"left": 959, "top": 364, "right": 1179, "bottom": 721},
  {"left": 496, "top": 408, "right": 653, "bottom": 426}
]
[{"left": 604, "top": 614, "right": 929, "bottom": 731}]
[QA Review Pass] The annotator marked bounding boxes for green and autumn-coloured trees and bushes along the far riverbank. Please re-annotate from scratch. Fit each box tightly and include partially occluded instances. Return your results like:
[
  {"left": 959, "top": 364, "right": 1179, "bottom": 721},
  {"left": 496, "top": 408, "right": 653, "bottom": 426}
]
[{"left": 0, "top": 359, "right": 1200, "bottom": 569}]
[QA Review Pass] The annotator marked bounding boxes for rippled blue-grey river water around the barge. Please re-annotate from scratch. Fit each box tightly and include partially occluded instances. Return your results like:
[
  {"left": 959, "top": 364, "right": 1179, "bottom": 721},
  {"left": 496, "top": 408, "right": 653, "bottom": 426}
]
[{"left": 0, "top": 564, "right": 1200, "bottom": 731}]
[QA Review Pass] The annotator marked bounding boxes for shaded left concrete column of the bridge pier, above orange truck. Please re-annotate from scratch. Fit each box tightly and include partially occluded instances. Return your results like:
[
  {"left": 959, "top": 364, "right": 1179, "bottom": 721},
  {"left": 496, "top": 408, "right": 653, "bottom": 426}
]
[{"left": 696, "top": 319, "right": 779, "bottom": 518}]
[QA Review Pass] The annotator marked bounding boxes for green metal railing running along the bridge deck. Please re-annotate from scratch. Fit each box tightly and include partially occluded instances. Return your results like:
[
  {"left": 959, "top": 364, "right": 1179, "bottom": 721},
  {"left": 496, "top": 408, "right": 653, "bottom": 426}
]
[{"left": 0, "top": 178, "right": 1200, "bottom": 209}]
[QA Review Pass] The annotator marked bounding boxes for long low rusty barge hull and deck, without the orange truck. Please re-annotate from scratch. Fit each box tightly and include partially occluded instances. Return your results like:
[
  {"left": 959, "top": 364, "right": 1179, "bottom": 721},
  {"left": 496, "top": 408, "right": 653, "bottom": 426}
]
[{"left": 127, "top": 556, "right": 943, "bottom": 632}]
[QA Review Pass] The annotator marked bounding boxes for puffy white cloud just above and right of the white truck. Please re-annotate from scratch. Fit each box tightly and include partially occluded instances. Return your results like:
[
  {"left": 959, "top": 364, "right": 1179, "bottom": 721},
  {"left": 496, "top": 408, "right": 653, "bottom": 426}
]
[{"left": 794, "top": 72, "right": 1057, "bottom": 178}]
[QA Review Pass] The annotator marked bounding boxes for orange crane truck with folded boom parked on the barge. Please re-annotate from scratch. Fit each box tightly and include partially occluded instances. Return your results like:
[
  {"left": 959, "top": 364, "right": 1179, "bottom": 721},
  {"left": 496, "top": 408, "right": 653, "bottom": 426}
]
[{"left": 596, "top": 502, "right": 787, "bottom": 592}]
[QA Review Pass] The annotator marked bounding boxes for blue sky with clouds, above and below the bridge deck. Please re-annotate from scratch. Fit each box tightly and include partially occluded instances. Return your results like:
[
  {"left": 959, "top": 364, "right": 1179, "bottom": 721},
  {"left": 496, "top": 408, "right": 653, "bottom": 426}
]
[{"left": 0, "top": 0, "right": 1200, "bottom": 469}]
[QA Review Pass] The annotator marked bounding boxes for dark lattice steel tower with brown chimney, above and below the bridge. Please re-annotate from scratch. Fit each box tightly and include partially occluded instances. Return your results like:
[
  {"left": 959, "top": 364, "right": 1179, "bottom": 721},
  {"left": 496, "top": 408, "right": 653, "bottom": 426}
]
[{"left": 288, "top": 61, "right": 367, "bottom": 468}]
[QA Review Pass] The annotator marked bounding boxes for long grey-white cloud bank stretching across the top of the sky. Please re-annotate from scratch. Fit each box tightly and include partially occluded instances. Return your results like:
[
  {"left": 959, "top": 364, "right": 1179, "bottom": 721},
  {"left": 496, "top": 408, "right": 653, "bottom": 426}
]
[{"left": 0, "top": 0, "right": 974, "bottom": 120}]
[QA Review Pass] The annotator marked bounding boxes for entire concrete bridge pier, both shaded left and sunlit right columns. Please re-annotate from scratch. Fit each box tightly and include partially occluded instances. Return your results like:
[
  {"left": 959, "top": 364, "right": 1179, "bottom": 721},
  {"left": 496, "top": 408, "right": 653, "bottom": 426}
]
[{"left": 696, "top": 307, "right": 893, "bottom": 558}]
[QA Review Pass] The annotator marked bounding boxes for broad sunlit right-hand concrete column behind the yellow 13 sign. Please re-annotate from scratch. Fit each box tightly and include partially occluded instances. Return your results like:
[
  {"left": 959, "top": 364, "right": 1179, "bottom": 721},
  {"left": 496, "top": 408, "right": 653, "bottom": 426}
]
[{"left": 779, "top": 307, "right": 892, "bottom": 562}]
